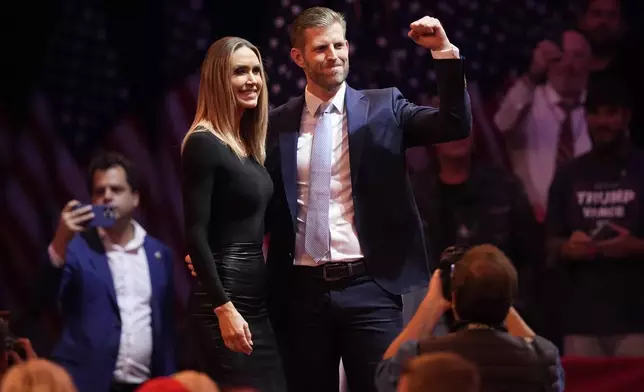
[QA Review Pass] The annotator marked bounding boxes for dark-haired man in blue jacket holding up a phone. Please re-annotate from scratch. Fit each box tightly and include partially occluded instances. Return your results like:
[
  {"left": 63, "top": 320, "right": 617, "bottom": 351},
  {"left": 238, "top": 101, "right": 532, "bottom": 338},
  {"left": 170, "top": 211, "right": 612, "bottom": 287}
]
[{"left": 45, "top": 153, "right": 175, "bottom": 392}]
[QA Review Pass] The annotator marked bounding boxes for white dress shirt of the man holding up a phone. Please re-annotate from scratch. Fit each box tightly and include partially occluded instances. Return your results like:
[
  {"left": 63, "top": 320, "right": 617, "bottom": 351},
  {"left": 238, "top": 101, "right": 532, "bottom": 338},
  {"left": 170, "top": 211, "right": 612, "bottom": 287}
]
[{"left": 49, "top": 221, "right": 153, "bottom": 384}]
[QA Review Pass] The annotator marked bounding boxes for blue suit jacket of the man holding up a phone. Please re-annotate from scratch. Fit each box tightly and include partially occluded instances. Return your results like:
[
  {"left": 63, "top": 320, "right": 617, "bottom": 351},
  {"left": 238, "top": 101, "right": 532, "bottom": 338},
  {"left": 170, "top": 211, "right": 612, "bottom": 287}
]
[{"left": 43, "top": 230, "right": 176, "bottom": 392}]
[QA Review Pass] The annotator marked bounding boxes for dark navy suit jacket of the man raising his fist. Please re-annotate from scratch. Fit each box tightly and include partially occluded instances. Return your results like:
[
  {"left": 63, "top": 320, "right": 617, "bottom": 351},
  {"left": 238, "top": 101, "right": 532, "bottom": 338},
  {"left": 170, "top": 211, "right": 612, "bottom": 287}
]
[{"left": 266, "top": 59, "right": 472, "bottom": 329}]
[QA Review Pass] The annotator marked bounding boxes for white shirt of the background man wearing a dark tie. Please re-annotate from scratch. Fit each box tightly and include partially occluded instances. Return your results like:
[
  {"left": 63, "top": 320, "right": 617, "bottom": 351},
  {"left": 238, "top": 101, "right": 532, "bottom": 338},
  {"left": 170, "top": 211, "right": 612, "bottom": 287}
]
[{"left": 494, "top": 80, "right": 591, "bottom": 208}]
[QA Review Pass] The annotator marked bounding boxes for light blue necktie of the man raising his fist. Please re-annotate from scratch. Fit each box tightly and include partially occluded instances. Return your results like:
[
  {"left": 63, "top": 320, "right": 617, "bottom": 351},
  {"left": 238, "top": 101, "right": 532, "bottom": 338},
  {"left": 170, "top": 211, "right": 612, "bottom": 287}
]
[{"left": 304, "top": 103, "right": 333, "bottom": 262}]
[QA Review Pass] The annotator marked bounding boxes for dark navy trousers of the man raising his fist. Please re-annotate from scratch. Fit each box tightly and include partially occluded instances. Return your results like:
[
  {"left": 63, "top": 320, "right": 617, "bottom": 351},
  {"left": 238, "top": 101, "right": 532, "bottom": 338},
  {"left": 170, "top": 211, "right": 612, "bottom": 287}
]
[{"left": 285, "top": 267, "right": 403, "bottom": 392}]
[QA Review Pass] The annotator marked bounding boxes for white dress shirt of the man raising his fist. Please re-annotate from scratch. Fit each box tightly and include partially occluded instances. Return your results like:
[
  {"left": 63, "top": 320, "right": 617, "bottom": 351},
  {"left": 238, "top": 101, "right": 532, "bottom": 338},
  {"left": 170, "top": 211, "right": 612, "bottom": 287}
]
[{"left": 294, "top": 46, "right": 460, "bottom": 266}]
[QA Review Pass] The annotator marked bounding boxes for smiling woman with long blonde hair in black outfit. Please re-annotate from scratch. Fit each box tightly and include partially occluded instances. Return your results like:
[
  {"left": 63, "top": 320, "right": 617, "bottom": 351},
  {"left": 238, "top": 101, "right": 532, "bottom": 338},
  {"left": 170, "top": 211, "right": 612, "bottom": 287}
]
[{"left": 182, "top": 37, "right": 285, "bottom": 391}]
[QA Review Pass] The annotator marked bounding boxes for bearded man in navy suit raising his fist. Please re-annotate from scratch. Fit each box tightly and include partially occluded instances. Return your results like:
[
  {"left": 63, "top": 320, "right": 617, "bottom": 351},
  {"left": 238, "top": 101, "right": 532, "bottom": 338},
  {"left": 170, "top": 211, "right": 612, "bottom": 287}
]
[{"left": 266, "top": 7, "right": 471, "bottom": 392}]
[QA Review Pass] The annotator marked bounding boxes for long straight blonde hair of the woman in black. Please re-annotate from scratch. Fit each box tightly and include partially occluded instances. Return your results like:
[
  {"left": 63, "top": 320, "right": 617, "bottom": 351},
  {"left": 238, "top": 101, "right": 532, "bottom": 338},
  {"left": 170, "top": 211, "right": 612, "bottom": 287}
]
[{"left": 182, "top": 37, "right": 268, "bottom": 164}]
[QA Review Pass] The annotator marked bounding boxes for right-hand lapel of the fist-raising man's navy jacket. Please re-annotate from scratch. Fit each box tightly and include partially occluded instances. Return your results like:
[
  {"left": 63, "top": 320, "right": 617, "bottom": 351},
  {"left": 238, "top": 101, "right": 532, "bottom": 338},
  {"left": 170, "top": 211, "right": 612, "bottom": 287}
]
[{"left": 345, "top": 86, "right": 369, "bottom": 186}]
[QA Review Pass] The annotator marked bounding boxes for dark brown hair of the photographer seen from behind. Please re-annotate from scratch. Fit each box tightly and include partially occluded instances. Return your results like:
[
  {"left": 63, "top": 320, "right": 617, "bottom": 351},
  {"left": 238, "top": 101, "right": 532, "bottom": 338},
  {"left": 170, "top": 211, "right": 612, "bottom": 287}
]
[{"left": 452, "top": 244, "right": 518, "bottom": 327}]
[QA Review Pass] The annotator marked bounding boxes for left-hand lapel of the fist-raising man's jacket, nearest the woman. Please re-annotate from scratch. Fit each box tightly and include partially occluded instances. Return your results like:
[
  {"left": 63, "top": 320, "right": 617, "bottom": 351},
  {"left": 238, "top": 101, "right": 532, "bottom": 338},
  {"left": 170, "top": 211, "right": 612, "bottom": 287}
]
[{"left": 278, "top": 96, "right": 304, "bottom": 225}]
